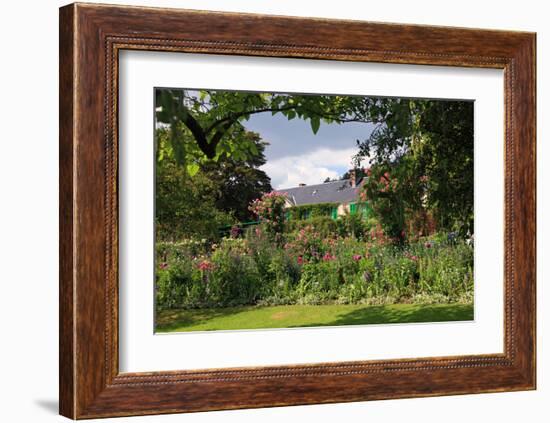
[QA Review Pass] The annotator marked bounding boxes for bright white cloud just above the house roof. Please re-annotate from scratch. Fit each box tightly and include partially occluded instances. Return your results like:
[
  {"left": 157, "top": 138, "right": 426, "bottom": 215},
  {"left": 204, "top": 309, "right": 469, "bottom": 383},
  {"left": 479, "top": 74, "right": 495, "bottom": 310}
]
[{"left": 261, "top": 148, "right": 357, "bottom": 189}]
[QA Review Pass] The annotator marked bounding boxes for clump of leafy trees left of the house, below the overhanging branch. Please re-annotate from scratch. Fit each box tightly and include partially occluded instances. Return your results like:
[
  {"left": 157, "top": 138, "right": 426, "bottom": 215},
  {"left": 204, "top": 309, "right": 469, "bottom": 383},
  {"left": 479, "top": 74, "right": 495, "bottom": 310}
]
[{"left": 156, "top": 128, "right": 272, "bottom": 240}]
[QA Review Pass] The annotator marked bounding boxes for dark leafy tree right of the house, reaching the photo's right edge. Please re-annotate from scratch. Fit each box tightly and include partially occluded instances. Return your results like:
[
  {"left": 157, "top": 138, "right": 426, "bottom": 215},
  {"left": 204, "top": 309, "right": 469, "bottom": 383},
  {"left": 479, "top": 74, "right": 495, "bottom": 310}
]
[{"left": 356, "top": 99, "right": 473, "bottom": 235}]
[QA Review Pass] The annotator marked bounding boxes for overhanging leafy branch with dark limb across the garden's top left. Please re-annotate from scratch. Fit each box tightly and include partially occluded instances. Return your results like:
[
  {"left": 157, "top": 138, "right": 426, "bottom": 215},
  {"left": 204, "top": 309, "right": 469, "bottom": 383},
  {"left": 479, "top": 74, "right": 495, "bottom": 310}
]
[{"left": 156, "top": 89, "right": 375, "bottom": 174}]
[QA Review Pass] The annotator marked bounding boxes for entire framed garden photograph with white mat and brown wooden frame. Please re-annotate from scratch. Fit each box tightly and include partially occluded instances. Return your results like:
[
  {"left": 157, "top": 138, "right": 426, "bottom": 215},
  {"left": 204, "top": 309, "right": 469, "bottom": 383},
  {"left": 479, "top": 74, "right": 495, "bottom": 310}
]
[{"left": 60, "top": 4, "right": 536, "bottom": 419}]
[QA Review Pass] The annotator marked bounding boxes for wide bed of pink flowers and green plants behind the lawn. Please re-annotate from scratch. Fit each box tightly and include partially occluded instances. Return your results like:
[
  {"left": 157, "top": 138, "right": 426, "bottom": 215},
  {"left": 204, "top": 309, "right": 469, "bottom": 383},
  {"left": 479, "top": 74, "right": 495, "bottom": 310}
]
[{"left": 156, "top": 234, "right": 473, "bottom": 308}]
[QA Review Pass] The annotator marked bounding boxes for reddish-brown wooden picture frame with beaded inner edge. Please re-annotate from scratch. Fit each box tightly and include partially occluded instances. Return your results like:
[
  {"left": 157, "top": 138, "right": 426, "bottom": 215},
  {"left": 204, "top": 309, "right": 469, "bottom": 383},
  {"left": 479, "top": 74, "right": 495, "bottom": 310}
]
[{"left": 59, "top": 4, "right": 536, "bottom": 419}]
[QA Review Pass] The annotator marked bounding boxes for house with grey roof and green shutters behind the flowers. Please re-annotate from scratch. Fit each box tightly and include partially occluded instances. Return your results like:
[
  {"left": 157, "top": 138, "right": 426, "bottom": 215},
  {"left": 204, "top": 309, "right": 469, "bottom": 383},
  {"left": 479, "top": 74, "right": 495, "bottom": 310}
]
[{"left": 277, "top": 172, "right": 369, "bottom": 219}]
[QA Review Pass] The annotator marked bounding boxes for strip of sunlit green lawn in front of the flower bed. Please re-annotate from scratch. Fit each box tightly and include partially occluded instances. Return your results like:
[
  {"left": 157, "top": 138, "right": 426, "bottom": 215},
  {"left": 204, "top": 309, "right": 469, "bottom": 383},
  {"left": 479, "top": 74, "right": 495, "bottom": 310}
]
[{"left": 156, "top": 304, "right": 474, "bottom": 332}]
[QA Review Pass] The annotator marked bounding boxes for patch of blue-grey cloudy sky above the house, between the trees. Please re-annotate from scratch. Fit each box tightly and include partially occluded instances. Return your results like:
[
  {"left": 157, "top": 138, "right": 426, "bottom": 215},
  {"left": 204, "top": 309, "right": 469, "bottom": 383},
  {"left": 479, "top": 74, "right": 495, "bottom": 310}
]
[{"left": 243, "top": 113, "right": 373, "bottom": 189}]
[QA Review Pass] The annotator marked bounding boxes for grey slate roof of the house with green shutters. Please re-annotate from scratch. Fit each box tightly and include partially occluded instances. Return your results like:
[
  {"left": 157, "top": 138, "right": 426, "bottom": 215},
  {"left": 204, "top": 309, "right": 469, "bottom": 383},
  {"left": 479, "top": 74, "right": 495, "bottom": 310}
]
[{"left": 277, "top": 179, "right": 364, "bottom": 206}]
